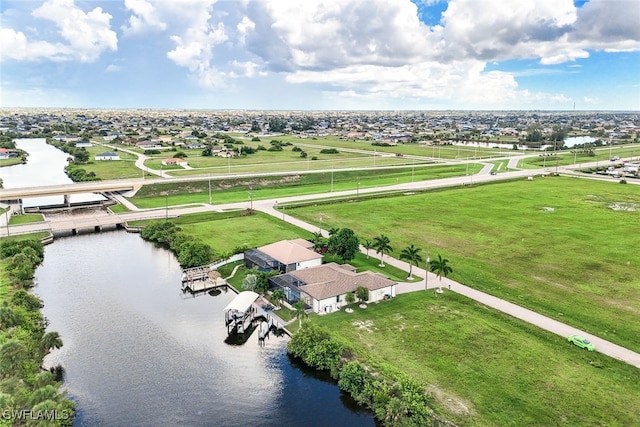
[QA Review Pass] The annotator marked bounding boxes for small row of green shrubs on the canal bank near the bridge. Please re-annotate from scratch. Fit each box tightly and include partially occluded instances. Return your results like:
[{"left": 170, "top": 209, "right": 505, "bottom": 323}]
[{"left": 140, "top": 221, "right": 213, "bottom": 268}]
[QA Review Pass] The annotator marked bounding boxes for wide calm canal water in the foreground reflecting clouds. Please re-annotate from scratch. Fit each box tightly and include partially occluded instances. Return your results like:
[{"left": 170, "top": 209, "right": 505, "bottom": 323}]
[{"left": 35, "top": 231, "right": 375, "bottom": 426}]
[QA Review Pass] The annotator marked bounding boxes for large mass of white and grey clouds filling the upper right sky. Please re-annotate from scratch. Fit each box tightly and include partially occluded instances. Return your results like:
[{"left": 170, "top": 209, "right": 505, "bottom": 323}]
[{"left": 238, "top": 0, "right": 640, "bottom": 105}]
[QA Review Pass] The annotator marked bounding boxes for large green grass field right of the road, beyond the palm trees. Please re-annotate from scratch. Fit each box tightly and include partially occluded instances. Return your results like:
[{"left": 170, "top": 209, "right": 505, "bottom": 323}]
[{"left": 287, "top": 177, "right": 640, "bottom": 351}]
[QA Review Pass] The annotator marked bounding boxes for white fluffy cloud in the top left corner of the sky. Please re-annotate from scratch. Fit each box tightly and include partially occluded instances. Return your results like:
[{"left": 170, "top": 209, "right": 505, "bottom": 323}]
[{"left": 0, "top": 0, "right": 118, "bottom": 62}]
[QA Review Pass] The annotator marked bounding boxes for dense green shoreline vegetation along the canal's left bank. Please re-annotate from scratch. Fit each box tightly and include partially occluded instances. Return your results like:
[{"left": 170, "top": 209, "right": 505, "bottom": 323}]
[{"left": 0, "top": 239, "right": 75, "bottom": 426}]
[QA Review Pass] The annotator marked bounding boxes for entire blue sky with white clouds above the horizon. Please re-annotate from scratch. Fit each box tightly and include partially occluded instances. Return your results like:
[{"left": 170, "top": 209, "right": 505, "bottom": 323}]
[{"left": 0, "top": 0, "right": 640, "bottom": 110}]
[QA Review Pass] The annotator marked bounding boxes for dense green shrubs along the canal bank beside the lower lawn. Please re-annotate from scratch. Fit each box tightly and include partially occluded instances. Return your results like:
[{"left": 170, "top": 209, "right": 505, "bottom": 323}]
[{"left": 287, "top": 323, "right": 442, "bottom": 427}]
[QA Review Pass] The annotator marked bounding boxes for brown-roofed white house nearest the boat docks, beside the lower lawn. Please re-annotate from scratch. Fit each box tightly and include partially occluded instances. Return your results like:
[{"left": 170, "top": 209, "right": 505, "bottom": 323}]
[{"left": 269, "top": 262, "right": 397, "bottom": 313}]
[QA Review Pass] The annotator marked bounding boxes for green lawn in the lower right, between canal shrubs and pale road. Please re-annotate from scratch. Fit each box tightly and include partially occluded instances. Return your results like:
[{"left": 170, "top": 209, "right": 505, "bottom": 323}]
[{"left": 311, "top": 292, "right": 640, "bottom": 426}]
